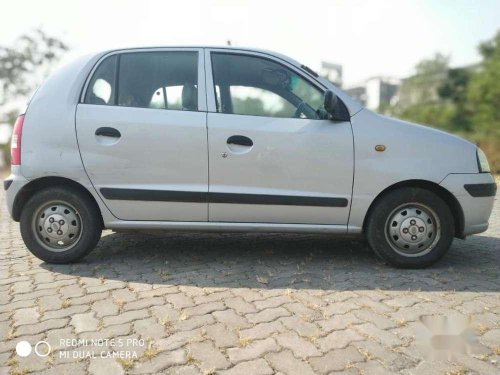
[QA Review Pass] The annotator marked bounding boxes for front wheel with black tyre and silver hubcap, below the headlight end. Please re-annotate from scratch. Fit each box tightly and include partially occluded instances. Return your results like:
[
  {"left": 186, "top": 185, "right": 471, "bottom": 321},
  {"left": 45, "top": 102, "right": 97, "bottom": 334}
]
[{"left": 365, "top": 188, "right": 455, "bottom": 268}]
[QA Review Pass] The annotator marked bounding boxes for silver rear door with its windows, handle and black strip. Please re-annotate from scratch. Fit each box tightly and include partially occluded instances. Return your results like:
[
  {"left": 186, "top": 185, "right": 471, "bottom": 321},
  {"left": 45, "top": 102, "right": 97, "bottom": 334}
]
[{"left": 76, "top": 48, "right": 208, "bottom": 221}]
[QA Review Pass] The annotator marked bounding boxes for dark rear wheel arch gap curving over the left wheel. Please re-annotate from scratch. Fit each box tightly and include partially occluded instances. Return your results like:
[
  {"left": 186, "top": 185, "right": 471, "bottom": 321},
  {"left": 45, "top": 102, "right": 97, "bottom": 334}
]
[{"left": 12, "top": 176, "right": 104, "bottom": 227}]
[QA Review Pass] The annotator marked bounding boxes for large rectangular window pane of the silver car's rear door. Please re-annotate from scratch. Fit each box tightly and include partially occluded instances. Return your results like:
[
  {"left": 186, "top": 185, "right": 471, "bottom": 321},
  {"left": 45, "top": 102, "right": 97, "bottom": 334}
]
[{"left": 118, "top": 52, "right": 198, "bottom": 111}]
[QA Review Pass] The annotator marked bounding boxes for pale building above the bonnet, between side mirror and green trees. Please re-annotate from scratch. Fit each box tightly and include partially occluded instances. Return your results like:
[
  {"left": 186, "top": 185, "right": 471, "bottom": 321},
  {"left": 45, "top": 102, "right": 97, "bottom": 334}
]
[{"left": 344, "top": 77, "right": 401, "bottom": 112}]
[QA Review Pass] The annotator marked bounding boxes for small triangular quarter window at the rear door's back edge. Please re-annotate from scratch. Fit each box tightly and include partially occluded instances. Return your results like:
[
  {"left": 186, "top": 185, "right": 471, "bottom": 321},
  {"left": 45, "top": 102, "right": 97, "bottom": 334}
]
[{"left": 84, "top": 55, "right": 117, "bottom": 105}]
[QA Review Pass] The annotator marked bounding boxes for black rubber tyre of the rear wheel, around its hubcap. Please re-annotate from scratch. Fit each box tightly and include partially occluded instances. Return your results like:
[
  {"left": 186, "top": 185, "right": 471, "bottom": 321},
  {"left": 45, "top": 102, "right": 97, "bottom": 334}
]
[{"left": 20, "top": 187, "right": 102, "bottom": 264}]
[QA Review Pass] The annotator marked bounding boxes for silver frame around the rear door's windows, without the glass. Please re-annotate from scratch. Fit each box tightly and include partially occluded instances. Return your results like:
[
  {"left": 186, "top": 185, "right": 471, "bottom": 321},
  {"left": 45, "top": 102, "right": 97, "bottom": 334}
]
[{"left": 77, "top": 47, "right": 207, "bottom": 112}]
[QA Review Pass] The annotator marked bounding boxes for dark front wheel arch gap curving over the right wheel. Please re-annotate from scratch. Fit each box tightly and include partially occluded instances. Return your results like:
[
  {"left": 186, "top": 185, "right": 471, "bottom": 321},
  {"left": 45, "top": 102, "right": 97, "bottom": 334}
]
[{"left": 363, "top": 180, "right": 465, "bottom": 239}]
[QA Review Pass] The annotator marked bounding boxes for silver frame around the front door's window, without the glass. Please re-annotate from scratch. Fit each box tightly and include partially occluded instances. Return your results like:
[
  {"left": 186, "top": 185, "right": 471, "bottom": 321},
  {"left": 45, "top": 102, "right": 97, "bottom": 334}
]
[{"left": 205, "top": 48, "right": 338, "bottom": 121}]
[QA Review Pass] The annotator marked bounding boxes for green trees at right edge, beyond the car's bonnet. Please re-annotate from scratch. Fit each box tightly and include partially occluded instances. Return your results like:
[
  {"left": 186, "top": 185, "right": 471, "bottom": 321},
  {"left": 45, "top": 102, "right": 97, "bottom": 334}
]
[{"left": 387, "top": 31, "right": 500, "bottom": 173}]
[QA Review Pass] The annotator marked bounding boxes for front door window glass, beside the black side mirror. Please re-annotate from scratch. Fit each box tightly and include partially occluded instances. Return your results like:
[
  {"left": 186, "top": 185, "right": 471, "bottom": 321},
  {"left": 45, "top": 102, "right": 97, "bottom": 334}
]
[{"left": 212, "top": 53, "right": 324, "bottom": 119}]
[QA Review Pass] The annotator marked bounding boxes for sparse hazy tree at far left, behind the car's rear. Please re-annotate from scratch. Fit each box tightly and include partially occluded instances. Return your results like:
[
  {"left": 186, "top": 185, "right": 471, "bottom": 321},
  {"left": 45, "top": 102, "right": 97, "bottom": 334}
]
[{"left": 0, "top": 29, "right": 68, "bottom": 166}]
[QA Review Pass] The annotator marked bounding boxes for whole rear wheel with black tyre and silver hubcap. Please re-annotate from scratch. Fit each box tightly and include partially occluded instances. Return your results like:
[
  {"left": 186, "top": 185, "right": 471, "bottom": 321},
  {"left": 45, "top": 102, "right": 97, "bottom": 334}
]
[{"left": 20, "top": 187, "right": 102, "bottom": 263}]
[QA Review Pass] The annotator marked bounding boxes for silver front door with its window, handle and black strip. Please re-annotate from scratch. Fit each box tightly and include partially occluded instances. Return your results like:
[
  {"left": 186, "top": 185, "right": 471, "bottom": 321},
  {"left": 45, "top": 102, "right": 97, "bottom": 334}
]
[{"left": 206, "top": 50, "right": 354, "bottom": 225}]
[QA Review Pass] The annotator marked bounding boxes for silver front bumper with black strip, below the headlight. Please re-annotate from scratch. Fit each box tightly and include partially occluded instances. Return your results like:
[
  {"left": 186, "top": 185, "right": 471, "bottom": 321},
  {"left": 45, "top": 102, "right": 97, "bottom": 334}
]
[{"left": 440, "top": 173, "right": 496, "bottom": 236}]
